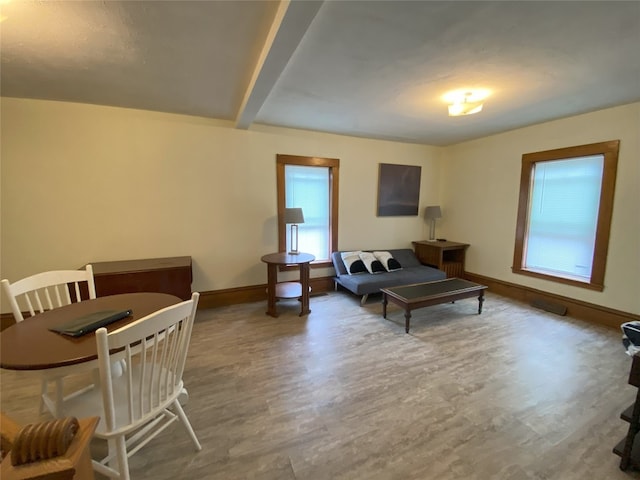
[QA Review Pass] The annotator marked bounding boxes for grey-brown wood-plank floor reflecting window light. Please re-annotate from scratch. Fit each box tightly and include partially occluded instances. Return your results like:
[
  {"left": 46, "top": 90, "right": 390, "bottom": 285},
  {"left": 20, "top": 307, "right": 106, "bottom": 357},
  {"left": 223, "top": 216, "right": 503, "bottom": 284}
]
[{"left": 1, "top": 292, "right": 640, "bottom": 480}]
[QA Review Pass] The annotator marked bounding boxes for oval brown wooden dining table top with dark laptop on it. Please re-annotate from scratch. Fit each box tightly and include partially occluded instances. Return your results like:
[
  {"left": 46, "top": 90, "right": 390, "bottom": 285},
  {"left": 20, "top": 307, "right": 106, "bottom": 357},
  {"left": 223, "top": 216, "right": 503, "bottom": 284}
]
[{"left": 0, "top": 293, "right": 182, "bottom": 370}]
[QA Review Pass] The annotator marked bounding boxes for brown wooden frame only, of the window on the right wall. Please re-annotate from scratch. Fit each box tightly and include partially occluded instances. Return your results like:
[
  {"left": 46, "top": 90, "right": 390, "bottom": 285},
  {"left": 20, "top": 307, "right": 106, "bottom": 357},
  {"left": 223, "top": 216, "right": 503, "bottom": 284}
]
[{"left": 512, "top": 140, "right": 620, "bottom": 291}]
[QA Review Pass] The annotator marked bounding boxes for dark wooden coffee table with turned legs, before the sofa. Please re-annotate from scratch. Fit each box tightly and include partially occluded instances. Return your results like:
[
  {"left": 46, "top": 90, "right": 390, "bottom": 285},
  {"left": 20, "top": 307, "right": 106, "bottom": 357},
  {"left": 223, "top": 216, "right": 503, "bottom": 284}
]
[{"left": 380, "top": 278, "right": 487, "bottom": 333}]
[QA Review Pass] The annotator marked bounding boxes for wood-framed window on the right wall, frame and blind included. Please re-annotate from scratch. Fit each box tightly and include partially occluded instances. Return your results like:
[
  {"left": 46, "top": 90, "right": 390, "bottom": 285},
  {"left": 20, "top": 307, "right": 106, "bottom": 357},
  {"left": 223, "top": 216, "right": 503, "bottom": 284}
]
[{"left": 513, "top": 140, "right": 620, "bottom": 291}]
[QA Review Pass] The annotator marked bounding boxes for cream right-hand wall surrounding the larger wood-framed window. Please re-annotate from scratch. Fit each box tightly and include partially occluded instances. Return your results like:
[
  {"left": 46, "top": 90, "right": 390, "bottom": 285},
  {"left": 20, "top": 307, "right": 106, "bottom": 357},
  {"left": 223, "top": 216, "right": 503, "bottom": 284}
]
[{"left": 439, "top": 103, "right": 640, "bottom": 314}]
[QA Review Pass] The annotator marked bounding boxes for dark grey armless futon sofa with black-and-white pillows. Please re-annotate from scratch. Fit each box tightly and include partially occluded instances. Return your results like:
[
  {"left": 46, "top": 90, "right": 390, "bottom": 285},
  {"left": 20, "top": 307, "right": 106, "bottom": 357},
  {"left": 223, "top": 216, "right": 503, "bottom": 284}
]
[{"left": 331, "top": 248, "right": 447, "bottom": 305}]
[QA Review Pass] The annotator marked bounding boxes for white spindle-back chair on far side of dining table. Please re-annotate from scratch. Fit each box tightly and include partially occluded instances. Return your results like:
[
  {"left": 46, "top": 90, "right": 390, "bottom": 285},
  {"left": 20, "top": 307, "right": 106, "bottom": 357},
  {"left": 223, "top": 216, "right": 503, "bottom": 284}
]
[{"left": 2, "top": 265, "right": 96, "bottom": 417}]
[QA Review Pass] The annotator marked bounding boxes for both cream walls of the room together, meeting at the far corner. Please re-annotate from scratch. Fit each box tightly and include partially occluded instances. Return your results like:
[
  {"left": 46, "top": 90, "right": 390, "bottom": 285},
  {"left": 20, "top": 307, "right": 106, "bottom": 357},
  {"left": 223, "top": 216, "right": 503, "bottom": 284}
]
[{"left": 0, "top": 98, "right": 640, "bottom": 314}]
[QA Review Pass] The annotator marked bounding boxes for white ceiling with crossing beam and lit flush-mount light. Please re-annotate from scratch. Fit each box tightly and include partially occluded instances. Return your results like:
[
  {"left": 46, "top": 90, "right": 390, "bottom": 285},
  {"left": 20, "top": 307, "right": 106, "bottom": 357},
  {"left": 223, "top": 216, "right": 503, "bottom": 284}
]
[{"left": 0, "top": 0, "right": 640, "bottom": 145}]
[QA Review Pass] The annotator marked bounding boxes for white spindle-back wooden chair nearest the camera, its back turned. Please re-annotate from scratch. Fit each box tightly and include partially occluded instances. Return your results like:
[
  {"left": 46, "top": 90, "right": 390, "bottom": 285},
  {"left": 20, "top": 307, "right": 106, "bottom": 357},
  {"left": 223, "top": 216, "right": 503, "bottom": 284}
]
[{"left": 60, "top": 292, "right": 201, "bottom": 480}]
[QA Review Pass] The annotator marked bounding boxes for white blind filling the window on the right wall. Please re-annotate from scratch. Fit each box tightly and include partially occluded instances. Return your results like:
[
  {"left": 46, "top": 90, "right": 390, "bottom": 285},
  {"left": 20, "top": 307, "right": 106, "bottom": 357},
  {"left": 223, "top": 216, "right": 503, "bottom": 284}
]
[{"left": 524, "top": 155, "right": 604, "bottom": 282}]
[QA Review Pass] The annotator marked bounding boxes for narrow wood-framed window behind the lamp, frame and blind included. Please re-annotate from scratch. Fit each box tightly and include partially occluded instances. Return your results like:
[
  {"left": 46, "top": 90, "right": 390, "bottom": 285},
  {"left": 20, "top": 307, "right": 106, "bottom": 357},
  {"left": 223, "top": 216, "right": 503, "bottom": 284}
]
[{"left": 276, "top": 155, "right": 340, "bottom": 266}]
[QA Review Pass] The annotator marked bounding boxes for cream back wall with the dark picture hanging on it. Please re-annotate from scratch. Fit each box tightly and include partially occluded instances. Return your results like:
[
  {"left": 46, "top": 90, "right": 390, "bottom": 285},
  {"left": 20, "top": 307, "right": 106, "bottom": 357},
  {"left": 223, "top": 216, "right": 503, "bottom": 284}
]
[{"left": 0, "top": 98, "right": 442, "bottom": 304}]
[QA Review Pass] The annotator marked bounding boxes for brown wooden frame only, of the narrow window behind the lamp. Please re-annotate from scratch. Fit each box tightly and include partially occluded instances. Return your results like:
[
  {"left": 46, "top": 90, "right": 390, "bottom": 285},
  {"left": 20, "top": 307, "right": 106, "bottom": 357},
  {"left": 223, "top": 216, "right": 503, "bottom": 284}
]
[{"left": 276, "top": 154, "right": 340, "bottom": 268}]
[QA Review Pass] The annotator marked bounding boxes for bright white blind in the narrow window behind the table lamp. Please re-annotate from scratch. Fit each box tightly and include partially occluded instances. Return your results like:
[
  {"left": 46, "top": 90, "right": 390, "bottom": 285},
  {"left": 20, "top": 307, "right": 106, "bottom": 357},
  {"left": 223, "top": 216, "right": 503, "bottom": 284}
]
[{"left": 284, "top": 165, "right": 331, "bottom": 261}]
